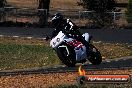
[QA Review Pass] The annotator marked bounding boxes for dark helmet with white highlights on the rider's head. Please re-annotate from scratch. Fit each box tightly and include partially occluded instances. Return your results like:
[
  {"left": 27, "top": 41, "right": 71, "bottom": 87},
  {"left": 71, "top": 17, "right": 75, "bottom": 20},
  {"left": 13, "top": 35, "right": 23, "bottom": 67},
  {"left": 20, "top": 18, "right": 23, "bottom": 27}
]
[{"left": 52, "top": 13, "right": 63, "bottom": 27}]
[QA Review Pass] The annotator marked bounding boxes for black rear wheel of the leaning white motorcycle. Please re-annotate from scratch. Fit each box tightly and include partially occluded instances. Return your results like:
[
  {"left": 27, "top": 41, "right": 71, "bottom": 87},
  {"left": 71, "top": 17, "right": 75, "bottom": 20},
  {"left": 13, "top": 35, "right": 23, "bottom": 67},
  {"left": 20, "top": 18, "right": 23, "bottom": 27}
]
[{"left": 89, "top": 44, "right": 102, "bottom": 65}]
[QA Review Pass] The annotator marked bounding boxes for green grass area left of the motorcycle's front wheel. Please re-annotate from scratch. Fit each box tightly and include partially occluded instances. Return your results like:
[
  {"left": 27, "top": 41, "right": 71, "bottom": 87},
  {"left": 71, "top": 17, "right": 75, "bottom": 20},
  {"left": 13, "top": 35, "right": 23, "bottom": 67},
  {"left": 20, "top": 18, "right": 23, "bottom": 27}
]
[{"left": 0, "top": 44, "right": 59, "bottom": 70}]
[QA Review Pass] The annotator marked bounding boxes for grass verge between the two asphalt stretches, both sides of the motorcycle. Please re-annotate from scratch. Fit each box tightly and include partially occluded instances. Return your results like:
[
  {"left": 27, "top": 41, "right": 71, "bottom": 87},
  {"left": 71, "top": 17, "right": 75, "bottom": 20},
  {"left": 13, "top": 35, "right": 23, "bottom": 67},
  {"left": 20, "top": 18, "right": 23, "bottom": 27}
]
[{"left": 0, "top": 37, "right": 132, "bottom": 70}]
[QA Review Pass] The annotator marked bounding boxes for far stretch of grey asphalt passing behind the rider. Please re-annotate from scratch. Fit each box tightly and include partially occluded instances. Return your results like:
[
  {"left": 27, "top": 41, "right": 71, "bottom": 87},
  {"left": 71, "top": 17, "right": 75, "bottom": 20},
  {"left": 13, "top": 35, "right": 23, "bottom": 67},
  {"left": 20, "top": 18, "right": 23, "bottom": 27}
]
[{"left": 0, "top": 27, "right": 132, "bottom": 44}]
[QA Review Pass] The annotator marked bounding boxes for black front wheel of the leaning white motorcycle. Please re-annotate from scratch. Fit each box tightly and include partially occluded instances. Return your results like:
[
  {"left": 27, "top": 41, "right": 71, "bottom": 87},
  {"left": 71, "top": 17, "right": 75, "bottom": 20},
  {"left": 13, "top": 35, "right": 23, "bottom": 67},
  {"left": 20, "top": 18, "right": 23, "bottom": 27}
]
[{"left": 56, "top": 43, "right": 76, "bottom": 67}]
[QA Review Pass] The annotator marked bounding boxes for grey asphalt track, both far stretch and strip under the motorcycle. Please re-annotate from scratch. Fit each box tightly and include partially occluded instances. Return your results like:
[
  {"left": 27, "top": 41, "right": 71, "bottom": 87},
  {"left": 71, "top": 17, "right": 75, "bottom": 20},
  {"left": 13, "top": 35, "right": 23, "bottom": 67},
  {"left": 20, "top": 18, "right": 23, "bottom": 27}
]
[{"left": 0, "top": 27, "right": 132, "bottom": 76}]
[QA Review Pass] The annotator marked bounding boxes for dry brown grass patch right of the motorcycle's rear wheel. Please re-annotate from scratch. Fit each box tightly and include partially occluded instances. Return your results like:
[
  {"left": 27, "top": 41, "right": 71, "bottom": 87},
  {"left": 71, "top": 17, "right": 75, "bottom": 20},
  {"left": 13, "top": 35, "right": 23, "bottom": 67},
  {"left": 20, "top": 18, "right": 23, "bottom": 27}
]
[{"left": 93, "top": 42, "right": 132, "bottom": 59}]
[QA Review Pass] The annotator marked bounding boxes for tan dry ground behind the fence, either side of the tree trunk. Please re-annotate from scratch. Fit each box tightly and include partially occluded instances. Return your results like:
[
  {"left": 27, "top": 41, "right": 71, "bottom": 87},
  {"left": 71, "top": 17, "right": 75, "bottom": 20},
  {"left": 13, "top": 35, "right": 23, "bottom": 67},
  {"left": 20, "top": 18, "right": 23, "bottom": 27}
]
[{"left": 7, "top": 0, "right": 83, "bottom": 10}]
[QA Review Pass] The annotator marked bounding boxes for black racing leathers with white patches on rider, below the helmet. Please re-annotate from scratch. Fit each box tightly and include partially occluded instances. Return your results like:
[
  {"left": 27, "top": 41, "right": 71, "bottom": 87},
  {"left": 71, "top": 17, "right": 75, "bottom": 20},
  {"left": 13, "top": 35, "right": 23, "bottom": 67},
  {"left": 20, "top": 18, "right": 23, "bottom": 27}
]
[{"left": 51, "top": 19, "right": 86, "bottom": 45}]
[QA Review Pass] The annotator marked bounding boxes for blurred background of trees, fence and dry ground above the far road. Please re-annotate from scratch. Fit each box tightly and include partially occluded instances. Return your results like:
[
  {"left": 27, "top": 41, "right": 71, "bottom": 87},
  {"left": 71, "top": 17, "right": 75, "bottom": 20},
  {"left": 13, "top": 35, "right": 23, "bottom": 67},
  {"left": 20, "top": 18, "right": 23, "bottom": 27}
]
[{"left": 0, "top": 0, "right": 132, "bottom": 28}]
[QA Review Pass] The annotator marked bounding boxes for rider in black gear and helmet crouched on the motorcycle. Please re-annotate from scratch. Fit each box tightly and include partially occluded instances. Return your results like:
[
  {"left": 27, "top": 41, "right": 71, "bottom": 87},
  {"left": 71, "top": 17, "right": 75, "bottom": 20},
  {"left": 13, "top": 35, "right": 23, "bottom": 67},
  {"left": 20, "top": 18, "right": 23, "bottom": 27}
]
[{"left": 51, "top": 13, "right": 89, "bottom": 53}]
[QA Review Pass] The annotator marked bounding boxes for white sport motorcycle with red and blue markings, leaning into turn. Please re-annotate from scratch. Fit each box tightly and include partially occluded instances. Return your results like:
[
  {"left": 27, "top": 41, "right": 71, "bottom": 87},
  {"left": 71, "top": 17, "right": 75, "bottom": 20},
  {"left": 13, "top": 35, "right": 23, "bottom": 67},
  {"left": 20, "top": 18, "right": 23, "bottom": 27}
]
[{"left": 50, "top": 31, "right": 102, "bottom": 67}]
